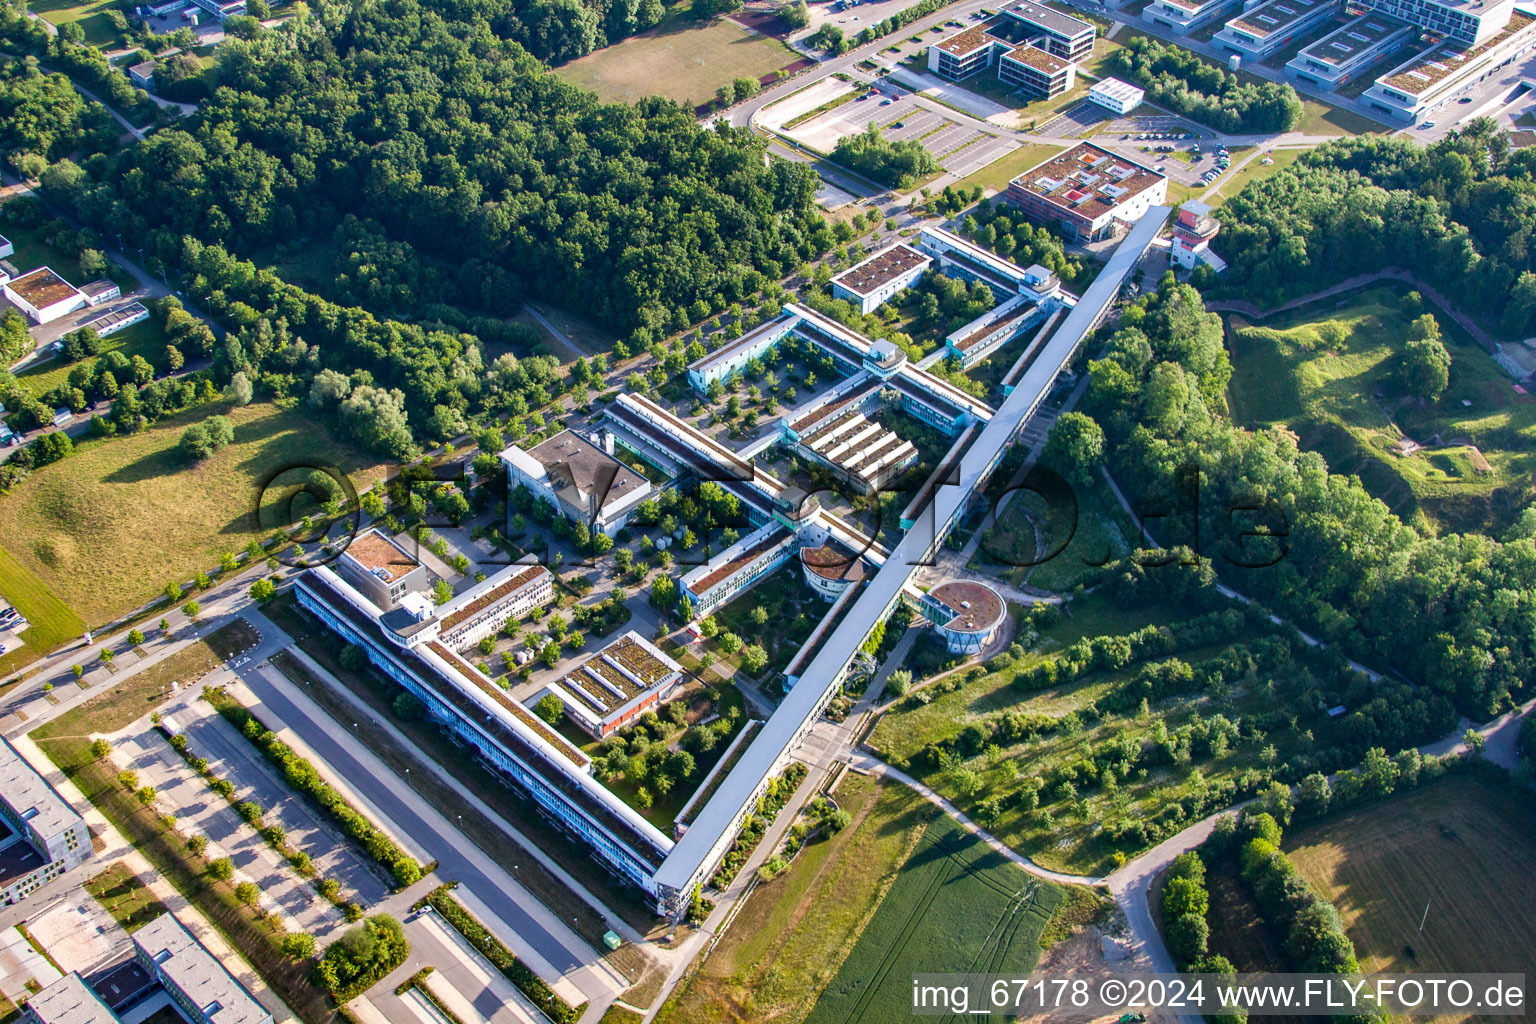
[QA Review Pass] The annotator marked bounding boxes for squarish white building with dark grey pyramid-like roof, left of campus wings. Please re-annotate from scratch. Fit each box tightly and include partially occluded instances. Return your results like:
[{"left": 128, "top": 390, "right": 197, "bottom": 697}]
[{"left": 501, "top": 430, "right": 654, "bottom": 536}]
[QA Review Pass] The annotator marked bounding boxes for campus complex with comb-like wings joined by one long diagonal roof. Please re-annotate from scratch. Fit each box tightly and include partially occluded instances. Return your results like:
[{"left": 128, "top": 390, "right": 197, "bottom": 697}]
[{"left": 285, "top": 207, "right": 1163, "bottom": 917}]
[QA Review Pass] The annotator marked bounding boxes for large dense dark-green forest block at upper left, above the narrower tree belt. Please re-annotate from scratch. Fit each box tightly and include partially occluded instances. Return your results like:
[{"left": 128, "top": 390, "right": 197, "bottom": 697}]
[{"left": 6, "top": 0, "right": 831, "bottom": 336}]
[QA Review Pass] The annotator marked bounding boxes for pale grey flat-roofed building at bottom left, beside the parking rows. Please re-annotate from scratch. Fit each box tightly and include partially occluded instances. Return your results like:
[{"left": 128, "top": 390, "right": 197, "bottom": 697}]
[{"left": 134, "top": 912, "right": 272, "bottom": 1024}]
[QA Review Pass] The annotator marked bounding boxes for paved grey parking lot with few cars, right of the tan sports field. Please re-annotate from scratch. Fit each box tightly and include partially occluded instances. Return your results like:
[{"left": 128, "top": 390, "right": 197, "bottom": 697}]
[{"left": 786, "top": 93, "right": 1018, "bottom": 177}]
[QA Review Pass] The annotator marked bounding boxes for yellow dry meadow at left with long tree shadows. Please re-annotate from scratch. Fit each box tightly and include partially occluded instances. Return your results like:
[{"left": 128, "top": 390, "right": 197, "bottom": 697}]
[{"left": 0, "top": 402, "right": 386, "bottom": 636}]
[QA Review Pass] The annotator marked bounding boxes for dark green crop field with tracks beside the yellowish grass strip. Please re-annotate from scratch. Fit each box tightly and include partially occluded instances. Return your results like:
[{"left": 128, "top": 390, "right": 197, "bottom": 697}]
[{"left": 806, "top": 817, "right": 1061, "bottom": 1024}]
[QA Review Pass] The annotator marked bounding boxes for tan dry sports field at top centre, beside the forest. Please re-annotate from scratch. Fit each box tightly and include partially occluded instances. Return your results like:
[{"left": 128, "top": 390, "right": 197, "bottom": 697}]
[{"left": 554, "top": 18, "right": 799, "bottom": 104}]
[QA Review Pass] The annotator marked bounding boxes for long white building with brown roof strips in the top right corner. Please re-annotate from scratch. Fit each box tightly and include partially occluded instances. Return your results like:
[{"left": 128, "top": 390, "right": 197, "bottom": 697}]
[{"left": 1361, "top": 6, "right": 1536, "bottom": 121}]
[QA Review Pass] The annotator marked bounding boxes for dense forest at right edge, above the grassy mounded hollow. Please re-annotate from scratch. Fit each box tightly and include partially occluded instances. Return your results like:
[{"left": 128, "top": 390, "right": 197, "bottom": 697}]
[{"left": 1216, "top": 118, "right": 1536, "bottom": 338}]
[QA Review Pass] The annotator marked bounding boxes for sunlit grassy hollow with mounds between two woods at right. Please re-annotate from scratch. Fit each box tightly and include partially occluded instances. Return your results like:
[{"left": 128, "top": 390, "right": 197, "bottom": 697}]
[{"left": 1229, "top": 287, "right": 1536, "bottom": 533}]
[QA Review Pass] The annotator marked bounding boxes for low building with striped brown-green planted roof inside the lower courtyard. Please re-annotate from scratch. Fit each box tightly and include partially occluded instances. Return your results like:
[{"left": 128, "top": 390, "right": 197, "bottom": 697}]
[{"left": 545, "top": 629, "right": 682, "bottom": 740}]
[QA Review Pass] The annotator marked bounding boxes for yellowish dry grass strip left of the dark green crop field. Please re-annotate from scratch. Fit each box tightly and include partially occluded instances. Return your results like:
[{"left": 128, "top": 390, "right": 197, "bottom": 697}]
[{"left": 656, "top": 774, "right": 940, "bottom": 1024}]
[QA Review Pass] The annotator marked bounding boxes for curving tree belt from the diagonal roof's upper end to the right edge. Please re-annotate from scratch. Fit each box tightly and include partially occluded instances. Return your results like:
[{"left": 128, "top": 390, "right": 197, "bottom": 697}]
[{"left": 1086, "top": 275, "right": 1536, "bottom": 718}]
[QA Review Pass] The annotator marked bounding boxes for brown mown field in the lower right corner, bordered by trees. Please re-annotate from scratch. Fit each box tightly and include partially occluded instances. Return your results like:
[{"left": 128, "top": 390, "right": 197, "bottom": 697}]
[{"left": 1284, "top": 775, "right": 1536, "bottom": 973}]
